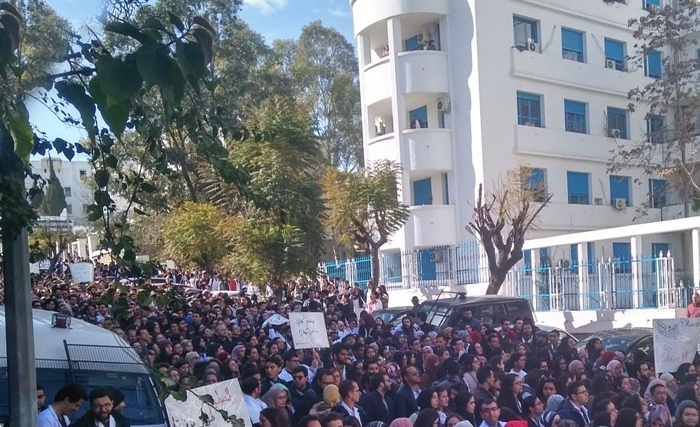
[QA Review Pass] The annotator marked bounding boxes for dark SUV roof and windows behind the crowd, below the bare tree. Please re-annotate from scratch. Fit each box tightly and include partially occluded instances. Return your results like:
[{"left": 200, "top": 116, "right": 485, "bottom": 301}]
[{"left": 391, "top": 292, "right": 535, "bottom": 331}]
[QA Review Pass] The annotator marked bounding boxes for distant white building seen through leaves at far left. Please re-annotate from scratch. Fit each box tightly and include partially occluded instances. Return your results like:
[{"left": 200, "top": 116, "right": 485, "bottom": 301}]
[{"left": 26, "top": 157, "right": 94, "bottom": 225}]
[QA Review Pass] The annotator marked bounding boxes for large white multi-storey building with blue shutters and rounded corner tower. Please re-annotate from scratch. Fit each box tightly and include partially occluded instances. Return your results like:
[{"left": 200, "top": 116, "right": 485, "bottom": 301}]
[{"left": 350, "top": 0, "right": 682, "bottom": 280}]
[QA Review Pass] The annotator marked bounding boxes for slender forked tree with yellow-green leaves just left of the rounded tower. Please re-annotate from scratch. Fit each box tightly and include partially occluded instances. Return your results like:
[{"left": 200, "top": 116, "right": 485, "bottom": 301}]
[{"left": 321, "top": 160, "right": 409, "bottom": 288}]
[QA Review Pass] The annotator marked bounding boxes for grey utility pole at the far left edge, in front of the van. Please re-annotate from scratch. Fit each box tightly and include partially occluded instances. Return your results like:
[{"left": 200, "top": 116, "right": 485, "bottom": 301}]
[{"left": 0, "top": 124, "right": 37, "bottom": 427}]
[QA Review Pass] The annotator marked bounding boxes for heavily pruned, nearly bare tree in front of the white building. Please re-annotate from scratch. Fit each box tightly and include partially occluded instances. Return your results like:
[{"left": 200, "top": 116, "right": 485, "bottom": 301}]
[{"left": 467, "top": 166, "right": 552, "bottom": 295}]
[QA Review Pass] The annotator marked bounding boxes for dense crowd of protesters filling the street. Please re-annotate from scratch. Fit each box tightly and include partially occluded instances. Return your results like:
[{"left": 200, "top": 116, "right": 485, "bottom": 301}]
[{"left": 6, "top": 260, "right": 700, "bottom": 427}]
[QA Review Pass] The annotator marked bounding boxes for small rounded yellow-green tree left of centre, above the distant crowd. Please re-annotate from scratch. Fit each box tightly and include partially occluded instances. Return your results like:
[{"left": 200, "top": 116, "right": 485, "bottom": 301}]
[{"left": 163, "top": 202, "right": 225, "bottom": 271}]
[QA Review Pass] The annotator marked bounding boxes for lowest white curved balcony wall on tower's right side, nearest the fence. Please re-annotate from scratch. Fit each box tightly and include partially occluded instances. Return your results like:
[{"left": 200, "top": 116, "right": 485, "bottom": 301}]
[{"left": 406, "top": 205, "right": 457, "bottom": 246}]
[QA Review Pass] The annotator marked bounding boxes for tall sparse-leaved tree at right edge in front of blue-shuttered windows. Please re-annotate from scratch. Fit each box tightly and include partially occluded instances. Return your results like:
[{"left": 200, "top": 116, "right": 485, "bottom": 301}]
[{"left": 608, "top": 0, "right": 700, "bottom": 281}]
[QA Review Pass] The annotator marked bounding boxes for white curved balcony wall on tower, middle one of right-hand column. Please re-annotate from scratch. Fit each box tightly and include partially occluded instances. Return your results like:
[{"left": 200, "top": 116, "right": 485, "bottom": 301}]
[{"left": 401, "top": 129, "right": 452, "bottom": 172}]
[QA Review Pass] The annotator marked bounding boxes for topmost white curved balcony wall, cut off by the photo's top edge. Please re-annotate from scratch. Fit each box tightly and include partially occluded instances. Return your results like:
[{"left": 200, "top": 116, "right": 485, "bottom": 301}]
[{"left": 350, "top": 0, "right": 450, "bottom": 36}]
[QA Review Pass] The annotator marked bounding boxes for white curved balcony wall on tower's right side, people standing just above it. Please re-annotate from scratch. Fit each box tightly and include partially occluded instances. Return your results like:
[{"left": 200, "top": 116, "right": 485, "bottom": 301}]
[{"left": 398, "top": 50, "right": 449, "bottom": 94}]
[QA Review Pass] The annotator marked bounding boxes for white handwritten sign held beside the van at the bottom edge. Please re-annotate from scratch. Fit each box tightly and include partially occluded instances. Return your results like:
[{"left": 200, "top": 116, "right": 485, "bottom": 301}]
[{"left": 165, "top": 379, "right": 252, "bottom": 427}]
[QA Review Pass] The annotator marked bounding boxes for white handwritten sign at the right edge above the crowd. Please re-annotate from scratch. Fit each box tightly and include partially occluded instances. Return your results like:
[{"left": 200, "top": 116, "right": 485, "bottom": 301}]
[{"left": 652, "top": 318, "right": 700, "bottom": 372}]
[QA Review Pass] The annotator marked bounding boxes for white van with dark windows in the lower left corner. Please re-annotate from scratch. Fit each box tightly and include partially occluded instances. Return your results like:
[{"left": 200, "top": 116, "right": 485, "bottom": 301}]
[{"left": 0, "top": 307, "right": 168, "bottom": 427}]
